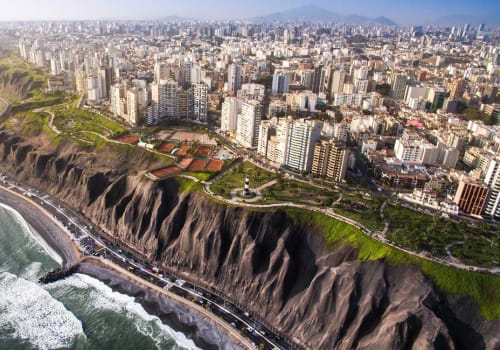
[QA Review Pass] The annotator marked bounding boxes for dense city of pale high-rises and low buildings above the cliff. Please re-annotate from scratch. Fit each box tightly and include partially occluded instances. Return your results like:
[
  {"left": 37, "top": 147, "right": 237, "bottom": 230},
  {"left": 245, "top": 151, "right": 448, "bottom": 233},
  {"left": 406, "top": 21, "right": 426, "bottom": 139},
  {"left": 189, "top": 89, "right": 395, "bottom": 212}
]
[{"left": 0, "top": 21, "right": 500, "bottom": 219}]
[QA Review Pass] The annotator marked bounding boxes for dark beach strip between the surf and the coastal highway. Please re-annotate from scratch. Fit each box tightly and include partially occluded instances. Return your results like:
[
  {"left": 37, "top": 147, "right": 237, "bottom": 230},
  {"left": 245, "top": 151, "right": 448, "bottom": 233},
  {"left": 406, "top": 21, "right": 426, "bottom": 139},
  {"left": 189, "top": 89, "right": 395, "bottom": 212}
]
[{"left": 0, "top": 186, "right": 241, "bottom": 350}]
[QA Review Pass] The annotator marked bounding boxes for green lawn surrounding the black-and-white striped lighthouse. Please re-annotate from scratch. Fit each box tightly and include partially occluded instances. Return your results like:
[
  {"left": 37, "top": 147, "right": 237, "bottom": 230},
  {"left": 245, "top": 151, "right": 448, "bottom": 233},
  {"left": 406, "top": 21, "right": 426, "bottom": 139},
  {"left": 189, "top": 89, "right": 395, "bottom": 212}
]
[{"left": 210, "top": 162, "right": 278, "bottom": 198}]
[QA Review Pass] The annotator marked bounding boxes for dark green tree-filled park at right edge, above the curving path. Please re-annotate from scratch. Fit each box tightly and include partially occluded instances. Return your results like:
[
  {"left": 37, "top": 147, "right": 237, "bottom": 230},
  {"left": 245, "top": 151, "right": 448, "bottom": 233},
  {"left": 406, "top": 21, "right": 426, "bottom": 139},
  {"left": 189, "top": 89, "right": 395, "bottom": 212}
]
[{"left": 384, "top": 205, "right": 500, "bottom": 267}]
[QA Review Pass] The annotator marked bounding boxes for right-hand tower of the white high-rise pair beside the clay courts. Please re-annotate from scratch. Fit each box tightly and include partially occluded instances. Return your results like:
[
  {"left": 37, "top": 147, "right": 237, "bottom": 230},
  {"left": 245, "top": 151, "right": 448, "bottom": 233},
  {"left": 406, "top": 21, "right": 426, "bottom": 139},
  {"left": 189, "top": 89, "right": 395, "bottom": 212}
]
[{"left": 236, "top": 100, "right": 263, "bottom": 148}]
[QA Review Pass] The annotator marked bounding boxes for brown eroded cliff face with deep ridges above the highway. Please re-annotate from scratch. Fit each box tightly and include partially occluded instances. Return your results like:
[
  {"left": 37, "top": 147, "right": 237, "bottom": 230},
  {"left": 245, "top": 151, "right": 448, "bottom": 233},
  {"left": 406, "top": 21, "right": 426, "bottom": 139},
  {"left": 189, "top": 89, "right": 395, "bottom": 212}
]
[{"left": 0, "top": 131, "right": 500, "bottom": 349}]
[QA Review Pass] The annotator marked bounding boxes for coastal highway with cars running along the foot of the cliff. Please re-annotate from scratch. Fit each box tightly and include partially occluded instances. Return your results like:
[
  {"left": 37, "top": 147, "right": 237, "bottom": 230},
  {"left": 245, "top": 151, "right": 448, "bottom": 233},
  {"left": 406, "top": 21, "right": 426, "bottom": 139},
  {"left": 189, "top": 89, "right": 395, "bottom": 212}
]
[{"left": 0, "top": 175, "right": 298, "bottom": 350}]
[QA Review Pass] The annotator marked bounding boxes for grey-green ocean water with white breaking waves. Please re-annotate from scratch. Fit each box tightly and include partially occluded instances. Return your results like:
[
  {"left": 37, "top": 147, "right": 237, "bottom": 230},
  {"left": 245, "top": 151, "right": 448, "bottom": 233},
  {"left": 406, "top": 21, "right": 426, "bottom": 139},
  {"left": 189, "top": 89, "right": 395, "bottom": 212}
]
[{"left": 0, "top": 204, "right": 198, "bottom": 350}]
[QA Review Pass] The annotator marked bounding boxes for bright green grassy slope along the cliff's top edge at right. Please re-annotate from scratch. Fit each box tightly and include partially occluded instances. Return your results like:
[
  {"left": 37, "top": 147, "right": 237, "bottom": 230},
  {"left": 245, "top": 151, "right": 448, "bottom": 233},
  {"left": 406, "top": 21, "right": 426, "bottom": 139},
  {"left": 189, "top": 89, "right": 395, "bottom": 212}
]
[{"left": 286, "top": 209, "right": 500, "bottom": 319}]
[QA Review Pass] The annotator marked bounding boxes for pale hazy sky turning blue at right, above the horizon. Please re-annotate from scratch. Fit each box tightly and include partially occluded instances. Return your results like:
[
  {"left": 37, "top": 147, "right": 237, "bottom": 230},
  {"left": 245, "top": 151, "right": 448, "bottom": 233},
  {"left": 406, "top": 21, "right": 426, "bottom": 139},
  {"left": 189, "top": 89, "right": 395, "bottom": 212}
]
[{"left": 0, "top": 0, "right": 500, "bottom": 23}]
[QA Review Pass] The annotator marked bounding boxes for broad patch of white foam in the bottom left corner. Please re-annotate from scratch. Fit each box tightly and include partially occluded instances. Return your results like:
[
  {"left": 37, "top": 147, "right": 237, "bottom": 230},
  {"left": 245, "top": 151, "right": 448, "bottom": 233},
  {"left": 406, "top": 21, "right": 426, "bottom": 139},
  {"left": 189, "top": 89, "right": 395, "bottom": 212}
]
[{"left": 0, "top": 272, "right": 84, "bottom": 350}]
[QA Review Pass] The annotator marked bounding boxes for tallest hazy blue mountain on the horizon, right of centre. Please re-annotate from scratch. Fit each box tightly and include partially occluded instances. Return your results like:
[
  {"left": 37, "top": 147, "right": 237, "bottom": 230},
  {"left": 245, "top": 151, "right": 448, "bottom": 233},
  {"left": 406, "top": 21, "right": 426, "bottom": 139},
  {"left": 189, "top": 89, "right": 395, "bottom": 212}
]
[{"left": 251, "top": 5, "right": 396, "bottom": 26}]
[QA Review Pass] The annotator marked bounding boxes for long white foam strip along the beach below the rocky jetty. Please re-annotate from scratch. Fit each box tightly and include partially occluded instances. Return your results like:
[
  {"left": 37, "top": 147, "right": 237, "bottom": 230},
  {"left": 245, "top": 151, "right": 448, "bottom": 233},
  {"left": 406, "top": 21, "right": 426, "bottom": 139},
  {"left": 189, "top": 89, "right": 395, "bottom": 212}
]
[{"left": 49, "top": 274, "right": 199, "bottom": 349}]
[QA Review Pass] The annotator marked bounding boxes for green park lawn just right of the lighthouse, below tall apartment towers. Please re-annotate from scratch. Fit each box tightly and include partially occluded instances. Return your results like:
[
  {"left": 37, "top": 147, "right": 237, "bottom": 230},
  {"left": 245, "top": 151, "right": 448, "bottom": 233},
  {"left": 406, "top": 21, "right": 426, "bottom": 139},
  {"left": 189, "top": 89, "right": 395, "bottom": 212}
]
[{"left": 262, "top": 180, "right": 339, "bottom": 206}]
